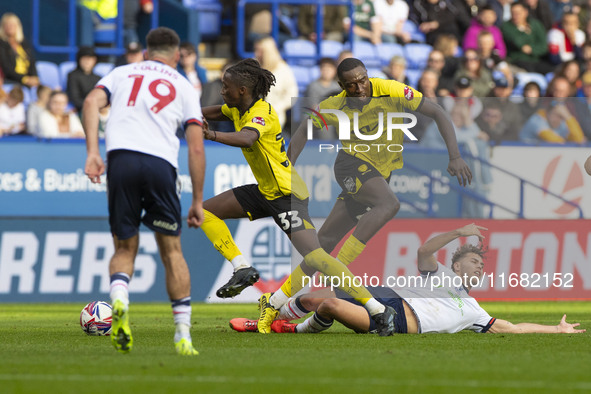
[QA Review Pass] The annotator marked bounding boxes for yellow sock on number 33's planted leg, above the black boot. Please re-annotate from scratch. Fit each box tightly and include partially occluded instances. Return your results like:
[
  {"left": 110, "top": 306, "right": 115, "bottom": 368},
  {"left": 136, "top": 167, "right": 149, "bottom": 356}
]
[{"left": 304, "top": 248, "right": 373, "bottom": 305}]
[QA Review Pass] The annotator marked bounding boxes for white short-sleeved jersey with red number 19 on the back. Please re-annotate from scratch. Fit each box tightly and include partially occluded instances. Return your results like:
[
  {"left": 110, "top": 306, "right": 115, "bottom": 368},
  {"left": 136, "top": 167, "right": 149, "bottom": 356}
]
[{"left": 96, "top": 60, "right": 202, "bottom": 168}]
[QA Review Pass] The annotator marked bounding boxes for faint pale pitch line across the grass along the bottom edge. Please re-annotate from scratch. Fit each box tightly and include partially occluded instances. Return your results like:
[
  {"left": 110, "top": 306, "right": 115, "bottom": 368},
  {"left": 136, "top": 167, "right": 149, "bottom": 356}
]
[{"left": 0, "top": 374, "right": 591, "bottom": 391}]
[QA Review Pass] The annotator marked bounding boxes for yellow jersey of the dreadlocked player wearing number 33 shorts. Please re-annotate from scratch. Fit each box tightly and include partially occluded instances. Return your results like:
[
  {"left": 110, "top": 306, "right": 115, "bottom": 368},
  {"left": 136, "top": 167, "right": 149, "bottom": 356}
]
[{"left": 222, "top": 100, "right": 308, "bottom": 200}]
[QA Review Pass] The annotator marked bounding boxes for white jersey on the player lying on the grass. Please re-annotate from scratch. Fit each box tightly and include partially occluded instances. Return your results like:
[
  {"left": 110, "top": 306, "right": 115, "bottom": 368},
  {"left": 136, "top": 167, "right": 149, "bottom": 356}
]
[{"left": 393, "top": 263, "right": 495, "bottom": 333}]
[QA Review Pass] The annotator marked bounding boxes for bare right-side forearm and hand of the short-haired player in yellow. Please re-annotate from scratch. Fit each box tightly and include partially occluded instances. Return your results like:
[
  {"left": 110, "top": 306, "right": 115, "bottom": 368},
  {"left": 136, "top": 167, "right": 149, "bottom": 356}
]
[{"left": 419, "top": 100, "right": 472, "bottom": 186}]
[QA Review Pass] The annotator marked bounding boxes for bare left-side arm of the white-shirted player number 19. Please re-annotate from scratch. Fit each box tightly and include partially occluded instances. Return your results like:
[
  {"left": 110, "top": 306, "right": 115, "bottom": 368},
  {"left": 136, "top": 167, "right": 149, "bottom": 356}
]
[{"left": 82, "top": 89, "right": 109, "bottom": 183}]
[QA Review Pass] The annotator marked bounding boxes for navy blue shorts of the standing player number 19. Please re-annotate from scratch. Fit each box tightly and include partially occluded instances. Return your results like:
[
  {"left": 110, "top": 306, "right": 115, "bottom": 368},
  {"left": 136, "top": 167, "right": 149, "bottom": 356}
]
[{"left": 107, "top": 150, "right": 181, "bottom": 239}]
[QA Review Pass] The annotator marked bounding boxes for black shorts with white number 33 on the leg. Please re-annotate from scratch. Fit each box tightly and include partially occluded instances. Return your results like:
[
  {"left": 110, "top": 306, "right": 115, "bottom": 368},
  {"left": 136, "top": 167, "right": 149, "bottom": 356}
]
[{"left": 232, "top": 184, "right": 314, "bottom": 235}]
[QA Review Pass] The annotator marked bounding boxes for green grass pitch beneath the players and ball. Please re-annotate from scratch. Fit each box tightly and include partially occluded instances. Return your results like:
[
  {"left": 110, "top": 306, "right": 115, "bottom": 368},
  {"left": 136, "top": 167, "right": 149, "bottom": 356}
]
[{"left": 0, "top": 302, "right": 591, "bottom": 394}]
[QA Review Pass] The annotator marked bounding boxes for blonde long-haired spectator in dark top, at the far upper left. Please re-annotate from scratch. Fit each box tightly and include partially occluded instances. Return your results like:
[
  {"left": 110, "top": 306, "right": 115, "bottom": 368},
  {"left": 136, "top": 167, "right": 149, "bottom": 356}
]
[{"left": 0, "top": 12, "right": 39, "bottom": 87}]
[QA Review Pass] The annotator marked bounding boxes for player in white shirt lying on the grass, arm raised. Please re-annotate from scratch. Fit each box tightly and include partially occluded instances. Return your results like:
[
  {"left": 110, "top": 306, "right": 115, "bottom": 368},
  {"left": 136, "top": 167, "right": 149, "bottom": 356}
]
[{"left": 230, "top": 224, "right": 585, "bottom": 334}]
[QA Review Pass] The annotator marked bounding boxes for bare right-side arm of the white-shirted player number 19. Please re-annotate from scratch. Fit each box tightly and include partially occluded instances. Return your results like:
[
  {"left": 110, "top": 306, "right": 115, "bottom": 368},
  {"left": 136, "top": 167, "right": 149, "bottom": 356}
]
[{"left": 185, "top": 124, "right": 205, "bottom": 228}]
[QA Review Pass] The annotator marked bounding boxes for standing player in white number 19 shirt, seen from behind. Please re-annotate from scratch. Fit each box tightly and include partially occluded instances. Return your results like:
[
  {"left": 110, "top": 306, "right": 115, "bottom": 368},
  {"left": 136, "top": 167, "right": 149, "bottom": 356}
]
[{"left": 82, "top": 27, "right": 205, "bottom": 355}]
